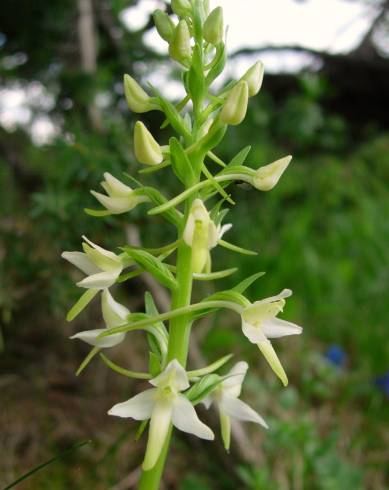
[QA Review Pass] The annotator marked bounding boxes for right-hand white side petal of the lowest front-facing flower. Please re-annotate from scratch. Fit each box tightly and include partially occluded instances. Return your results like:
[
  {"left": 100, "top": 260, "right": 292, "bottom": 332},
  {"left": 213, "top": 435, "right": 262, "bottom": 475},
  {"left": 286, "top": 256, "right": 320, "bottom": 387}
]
[{"left": 172, "top": 395, "right": 215, "bottom": 441}]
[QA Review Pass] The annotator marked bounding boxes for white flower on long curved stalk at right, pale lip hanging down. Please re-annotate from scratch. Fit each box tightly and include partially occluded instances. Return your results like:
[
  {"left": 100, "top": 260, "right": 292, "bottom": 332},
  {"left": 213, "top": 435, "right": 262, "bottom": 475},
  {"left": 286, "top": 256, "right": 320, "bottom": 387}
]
[{"left": 241, "top": 289, "right": 303, "bottom": 386}]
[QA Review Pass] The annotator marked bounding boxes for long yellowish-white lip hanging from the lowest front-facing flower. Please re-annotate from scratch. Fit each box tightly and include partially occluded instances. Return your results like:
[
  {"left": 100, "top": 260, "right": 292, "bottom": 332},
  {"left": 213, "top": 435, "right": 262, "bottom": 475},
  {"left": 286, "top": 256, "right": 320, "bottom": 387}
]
[{"left": 142, "top": 401, "right": 172, "bottom": 471}]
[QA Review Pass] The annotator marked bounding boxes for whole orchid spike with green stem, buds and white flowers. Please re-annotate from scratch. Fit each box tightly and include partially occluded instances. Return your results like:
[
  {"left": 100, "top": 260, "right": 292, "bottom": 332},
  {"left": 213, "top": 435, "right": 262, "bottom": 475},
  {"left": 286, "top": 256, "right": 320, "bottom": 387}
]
[{"left": 62, "top": 0, "right": 302, "bottom": 490}]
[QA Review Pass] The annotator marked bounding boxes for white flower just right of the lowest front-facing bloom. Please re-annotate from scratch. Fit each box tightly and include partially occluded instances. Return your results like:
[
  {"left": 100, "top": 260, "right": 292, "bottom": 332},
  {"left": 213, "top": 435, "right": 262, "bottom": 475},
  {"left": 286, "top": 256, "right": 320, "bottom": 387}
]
[{"left": 203, "top": 361, "right": 268, "bottom": 451}]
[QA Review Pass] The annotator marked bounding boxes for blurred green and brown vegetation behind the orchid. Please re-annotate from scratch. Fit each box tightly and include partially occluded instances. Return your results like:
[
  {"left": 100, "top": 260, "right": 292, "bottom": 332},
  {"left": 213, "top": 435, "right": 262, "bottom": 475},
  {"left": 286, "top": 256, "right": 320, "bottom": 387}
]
[{"left": 0, "top": 0, "right": 389, "bottom": 490}]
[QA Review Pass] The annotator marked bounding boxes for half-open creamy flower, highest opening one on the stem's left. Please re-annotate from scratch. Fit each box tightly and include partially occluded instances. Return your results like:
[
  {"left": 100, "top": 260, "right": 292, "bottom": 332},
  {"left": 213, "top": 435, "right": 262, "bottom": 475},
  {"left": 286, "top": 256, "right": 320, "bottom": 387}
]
[{"left": 91, "top": 172, "right": 148, "bottom": 214}]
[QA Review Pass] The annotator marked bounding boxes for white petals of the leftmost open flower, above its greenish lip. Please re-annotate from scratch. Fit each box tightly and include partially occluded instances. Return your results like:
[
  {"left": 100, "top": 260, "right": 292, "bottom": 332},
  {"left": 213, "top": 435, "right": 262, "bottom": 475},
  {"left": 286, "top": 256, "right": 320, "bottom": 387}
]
[{"left": 62, "top": 236, "right": 123, "bottom": 290}]
